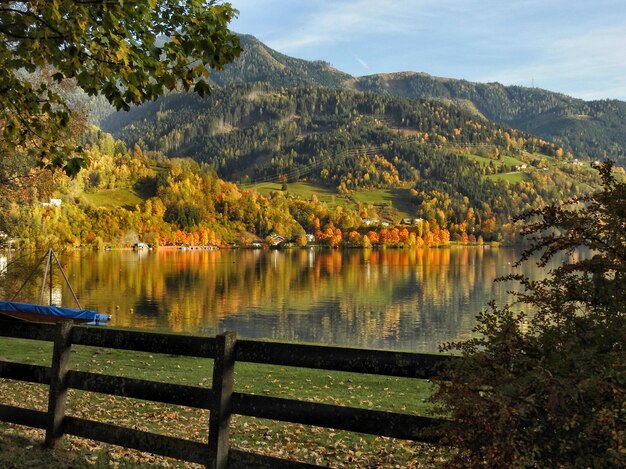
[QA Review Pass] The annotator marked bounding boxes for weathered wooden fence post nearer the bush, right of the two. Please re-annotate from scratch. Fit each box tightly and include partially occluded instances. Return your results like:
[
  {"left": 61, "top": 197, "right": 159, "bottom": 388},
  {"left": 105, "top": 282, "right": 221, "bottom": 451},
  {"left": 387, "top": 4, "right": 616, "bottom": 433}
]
[{"left": 207, "top": 332, "right": 237, "bottom": 469}]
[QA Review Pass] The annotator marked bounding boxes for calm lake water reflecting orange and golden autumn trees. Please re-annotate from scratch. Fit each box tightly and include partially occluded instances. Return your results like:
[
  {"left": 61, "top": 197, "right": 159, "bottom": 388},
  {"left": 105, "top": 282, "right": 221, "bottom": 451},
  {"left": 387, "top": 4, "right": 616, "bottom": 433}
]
[{"left": 0, "top": 247, "right": 564, "bottom": 352}]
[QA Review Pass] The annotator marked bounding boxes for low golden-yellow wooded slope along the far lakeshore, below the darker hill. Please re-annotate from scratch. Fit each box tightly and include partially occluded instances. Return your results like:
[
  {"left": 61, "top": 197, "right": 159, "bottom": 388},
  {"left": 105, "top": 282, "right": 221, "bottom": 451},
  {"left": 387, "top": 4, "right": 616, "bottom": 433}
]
[{"left": 0, "top": 129, "right": 464, "bottom": 249}]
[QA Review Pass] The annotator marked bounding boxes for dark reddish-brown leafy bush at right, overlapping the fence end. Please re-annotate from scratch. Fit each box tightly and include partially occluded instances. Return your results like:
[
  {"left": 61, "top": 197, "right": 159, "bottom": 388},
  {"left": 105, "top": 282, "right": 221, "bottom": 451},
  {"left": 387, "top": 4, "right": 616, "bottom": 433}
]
[{"left": 433, "top": 163, "right": 626, "bottom": 468}]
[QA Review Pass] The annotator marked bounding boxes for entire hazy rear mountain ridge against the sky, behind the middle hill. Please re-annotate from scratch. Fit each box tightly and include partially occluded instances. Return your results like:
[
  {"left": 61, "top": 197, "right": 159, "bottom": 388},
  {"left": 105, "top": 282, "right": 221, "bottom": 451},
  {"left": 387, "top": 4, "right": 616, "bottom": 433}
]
[{"left": 149, "top": 35, "right": 626, "bottom": 164}]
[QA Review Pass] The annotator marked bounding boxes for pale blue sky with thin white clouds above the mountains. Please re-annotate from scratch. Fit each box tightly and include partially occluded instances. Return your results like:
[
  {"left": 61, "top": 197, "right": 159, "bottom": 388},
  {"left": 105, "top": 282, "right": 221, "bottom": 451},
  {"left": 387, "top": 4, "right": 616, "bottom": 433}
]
[{"left": 230, "top": 0, "right": 626, "bottom": 101}]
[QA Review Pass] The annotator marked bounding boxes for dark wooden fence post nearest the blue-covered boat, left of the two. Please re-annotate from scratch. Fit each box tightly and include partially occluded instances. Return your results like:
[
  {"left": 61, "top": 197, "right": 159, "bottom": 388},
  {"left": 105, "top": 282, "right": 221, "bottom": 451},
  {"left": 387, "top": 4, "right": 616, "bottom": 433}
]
[{"left": 45, "top": 321, "right": 72, "bottom": 447}]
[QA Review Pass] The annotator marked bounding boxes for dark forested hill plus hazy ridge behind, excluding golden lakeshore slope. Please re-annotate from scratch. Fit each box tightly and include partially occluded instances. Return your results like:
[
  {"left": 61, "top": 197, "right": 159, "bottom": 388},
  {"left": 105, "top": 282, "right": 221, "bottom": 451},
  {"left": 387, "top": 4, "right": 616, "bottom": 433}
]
[{"left": 102, "top": 36, "right": 625, "bottom": 238}]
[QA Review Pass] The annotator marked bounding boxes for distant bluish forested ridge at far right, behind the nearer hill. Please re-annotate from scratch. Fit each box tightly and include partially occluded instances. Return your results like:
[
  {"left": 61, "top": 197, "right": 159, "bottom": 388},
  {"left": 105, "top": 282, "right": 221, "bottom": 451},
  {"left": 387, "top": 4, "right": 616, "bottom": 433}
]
[{"left": 344, "top": 72, "right": 626, "bottom": 164}]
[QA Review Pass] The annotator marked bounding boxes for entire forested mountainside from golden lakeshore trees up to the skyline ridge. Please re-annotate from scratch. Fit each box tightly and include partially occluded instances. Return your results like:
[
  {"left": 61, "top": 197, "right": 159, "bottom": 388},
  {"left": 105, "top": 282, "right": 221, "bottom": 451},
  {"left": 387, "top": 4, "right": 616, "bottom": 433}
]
[{"left": 7, "top": 36, "right": 626, "bottom": 247}]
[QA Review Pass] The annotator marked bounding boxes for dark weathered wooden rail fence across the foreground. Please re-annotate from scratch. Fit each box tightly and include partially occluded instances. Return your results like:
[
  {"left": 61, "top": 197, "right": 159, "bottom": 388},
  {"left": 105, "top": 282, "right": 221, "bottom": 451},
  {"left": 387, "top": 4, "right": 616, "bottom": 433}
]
[{"left": 0, "top": 322, "right": 450, "bottom": 469}]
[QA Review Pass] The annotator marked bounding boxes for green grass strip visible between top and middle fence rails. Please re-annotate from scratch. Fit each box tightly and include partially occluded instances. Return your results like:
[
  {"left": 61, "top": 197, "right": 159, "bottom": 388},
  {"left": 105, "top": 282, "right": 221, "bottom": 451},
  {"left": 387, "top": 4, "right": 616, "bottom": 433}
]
[{"left": 0, "top": 339, "right": 431, "bottom": 414}]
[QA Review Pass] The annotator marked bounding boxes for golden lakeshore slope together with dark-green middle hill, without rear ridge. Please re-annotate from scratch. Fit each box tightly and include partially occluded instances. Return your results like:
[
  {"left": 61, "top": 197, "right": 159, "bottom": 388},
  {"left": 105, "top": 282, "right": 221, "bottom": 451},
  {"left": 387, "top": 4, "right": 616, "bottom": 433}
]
[{"left": 0, "top": 110, "right": 598, "bottom": 252}]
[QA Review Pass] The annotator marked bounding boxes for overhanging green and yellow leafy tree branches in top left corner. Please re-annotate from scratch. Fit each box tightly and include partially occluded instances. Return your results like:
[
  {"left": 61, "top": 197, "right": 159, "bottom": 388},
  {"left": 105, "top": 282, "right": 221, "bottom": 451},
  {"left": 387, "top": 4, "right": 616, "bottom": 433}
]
[{"left": 0, "top": 0, "right": 241, "bottom": 174}]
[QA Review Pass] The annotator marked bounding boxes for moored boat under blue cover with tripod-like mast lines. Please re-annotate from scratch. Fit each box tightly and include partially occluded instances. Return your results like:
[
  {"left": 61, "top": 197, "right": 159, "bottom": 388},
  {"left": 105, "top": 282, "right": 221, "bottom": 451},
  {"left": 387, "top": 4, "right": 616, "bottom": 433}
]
[{"left": 0, "top": 249, "right": 111, "bottom": 326}]
